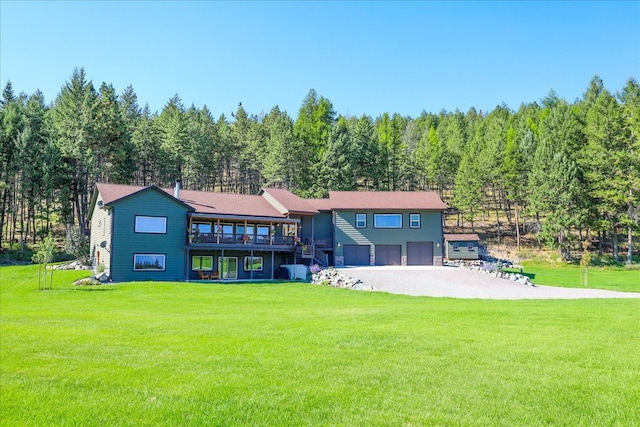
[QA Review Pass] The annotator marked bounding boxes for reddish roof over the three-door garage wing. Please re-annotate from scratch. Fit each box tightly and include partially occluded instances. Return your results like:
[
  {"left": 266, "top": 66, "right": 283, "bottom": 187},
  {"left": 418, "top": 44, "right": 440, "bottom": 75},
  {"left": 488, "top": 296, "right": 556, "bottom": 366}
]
[{"left": 329, "top": 191, "right": 447, "bottom": 210}]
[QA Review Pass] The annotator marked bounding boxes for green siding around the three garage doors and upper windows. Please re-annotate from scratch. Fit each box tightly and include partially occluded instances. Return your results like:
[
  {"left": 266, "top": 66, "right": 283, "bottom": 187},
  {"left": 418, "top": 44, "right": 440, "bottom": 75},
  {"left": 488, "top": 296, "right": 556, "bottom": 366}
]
[{"left": 334, "top": 210, "right": 442, "bottom": 260}]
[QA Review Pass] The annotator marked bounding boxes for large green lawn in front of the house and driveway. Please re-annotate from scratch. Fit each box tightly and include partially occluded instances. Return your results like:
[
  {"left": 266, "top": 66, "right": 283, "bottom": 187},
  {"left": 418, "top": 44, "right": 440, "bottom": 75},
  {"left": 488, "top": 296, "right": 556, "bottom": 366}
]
[{"left": 0, "top": 266, "right": 640, "bottom": 427}]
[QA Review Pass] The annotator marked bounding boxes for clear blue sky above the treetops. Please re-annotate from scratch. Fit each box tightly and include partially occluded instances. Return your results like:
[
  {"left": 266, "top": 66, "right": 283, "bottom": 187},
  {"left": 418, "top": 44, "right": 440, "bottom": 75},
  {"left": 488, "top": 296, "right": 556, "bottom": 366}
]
[{"left": 0, "top": 0, "right": 640, "bottom": 118}]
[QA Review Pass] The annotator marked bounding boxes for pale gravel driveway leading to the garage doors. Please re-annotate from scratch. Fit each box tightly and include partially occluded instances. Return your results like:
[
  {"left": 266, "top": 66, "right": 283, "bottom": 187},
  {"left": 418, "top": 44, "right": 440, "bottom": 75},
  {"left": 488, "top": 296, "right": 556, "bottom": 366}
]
[{"left": 338, "top": 266, "right": 640, "bottom": 299}]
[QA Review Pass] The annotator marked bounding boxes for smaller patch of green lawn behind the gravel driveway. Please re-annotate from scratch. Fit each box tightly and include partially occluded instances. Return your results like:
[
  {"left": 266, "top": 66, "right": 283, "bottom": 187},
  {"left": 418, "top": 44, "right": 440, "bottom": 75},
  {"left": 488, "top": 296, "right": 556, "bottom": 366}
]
[{"left": 507, "top": 262, "right": 640, "bottom": 292}]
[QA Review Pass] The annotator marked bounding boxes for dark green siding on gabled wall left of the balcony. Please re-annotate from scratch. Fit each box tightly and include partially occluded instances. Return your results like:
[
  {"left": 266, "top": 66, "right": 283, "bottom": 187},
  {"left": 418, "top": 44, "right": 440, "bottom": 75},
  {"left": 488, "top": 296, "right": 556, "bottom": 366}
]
[{"left": 111, "top": 188, "right": 188, "bottom": 282}]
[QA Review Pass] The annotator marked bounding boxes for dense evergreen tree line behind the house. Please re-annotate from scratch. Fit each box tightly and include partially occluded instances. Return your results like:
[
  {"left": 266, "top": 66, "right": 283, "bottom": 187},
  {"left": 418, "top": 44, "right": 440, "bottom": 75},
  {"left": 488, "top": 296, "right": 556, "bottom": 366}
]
[{"left": 0, "top": 69, "right": 640, "bottom": 262}]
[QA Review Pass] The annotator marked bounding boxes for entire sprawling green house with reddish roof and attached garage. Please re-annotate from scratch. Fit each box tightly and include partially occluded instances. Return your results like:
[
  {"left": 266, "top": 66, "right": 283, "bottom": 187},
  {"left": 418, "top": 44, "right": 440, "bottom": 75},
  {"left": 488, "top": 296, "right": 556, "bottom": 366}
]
[{"left": 89, "top": 182, "right": 445, "bottom": 282}]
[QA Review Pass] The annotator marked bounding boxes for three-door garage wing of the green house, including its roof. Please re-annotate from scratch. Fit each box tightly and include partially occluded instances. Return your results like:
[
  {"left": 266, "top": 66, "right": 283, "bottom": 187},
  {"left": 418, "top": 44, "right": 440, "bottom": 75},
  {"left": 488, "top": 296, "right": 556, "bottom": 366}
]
[{"left": 309, "top": 191, "right": 446, "bottom": 266}]
